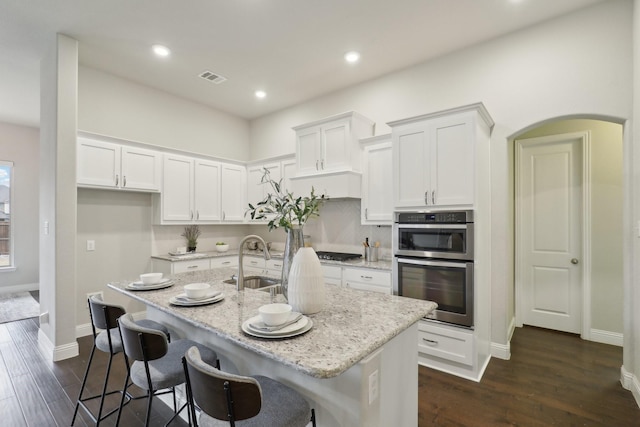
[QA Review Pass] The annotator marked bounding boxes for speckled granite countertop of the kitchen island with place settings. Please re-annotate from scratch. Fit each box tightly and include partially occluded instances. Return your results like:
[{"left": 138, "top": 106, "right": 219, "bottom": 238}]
[{"left": 109, "top": 268, "right": 437, "bottom": 378}]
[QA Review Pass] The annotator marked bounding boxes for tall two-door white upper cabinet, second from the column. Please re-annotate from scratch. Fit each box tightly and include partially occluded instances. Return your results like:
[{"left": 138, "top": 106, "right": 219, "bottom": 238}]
[{"left": 161, "top": 154, "right": 221, "bottom": 223}]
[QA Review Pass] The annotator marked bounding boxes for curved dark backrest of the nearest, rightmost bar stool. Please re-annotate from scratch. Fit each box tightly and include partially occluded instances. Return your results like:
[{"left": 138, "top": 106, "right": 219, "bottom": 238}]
[{"left": 185, "top": 347, "right": 262, "bottom": 425}]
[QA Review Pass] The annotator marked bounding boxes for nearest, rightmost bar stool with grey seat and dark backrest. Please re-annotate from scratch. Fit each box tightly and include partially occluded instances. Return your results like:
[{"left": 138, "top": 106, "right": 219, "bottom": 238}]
[{"left": 182, "top": 347, "right": 316, "bottom": 427}]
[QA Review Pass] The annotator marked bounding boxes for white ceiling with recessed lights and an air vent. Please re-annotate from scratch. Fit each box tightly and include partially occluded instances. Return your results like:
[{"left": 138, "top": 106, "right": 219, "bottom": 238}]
[{"left": 0, "top": 0, "right": 612, "bottom": 126}]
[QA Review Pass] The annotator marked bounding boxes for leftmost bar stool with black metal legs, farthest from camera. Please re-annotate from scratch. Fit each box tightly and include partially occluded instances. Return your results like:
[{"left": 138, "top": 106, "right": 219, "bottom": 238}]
[{"left": 71, "top": 295, "right": 169, "bottom": 426}]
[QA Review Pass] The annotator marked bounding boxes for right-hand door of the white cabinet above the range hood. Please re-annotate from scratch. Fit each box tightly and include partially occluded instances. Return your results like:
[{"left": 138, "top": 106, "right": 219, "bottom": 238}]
[{"left": 320, "top": 121, "right": 351, "bottom": 172}]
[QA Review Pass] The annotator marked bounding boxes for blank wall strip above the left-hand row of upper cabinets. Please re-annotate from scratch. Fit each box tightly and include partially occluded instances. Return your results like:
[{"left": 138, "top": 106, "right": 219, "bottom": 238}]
[{"left": 78, "top": 67, "right": 249, "bottom": 160}]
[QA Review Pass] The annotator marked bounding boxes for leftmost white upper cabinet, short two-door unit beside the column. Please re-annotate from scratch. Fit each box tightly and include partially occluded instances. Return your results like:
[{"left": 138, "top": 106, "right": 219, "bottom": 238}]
[{"left": 77, "top": 137, "right": 161, "bottom": 192}]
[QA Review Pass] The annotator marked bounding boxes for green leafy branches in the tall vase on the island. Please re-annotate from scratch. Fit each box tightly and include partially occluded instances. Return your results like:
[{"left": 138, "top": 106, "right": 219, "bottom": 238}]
[{"left": 245, "top": 168, "right": 328, "bottom": 231}]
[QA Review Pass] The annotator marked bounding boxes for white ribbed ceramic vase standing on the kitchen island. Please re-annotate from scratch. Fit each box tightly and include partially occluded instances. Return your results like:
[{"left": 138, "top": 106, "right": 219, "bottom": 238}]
[{"left": 287, "top": 248, "right": 325, "bottom": 314}]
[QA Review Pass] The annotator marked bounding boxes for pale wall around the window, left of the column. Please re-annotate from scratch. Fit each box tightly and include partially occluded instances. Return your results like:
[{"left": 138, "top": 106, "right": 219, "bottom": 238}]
[{"left": 0, "top": 123, "right": 40, "bottom": 293}]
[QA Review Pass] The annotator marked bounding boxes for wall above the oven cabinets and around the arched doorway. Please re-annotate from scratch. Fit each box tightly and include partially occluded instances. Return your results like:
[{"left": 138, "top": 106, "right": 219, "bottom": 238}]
[{"left": 251, "top": 1, "right": 632, "bottom": 352}]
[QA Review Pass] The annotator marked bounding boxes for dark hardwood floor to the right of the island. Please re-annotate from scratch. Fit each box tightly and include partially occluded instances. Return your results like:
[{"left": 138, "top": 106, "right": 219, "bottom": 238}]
[{"left": 419, "top": 327, "right": 640, "bottom": 427}]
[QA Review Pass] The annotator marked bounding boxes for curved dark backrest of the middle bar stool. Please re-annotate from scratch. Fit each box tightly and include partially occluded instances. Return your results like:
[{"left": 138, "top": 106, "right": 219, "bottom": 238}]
[{"left": 118, "top": 314, "right": 169, "bottom": 362}]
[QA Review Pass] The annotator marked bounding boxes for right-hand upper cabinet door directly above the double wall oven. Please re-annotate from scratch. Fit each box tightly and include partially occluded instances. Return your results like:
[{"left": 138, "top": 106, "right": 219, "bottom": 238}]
[{"left": 430, "top": 117, "right": 475, "bottom": 205}]
